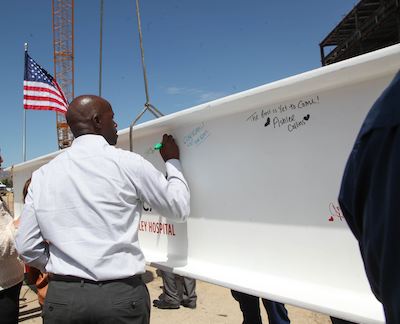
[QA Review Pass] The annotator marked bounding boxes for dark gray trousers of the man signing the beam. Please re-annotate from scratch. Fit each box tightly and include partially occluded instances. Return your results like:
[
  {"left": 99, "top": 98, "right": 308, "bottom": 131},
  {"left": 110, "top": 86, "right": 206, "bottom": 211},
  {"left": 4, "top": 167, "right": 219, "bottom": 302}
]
[{"left": 42, "top": 277, "right": 150, "bottom": 324}]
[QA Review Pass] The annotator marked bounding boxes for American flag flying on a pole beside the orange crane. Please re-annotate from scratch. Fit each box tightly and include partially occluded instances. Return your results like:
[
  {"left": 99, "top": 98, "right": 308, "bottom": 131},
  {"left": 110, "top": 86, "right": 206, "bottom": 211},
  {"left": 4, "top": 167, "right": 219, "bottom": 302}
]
[{"left": 24, "top": 52, "right": 69, "bottom": 114}]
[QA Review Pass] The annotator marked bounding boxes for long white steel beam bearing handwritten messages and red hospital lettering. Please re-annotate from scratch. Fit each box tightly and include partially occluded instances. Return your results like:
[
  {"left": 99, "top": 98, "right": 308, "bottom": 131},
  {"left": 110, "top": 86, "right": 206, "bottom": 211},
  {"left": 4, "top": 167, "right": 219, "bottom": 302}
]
[{"left": 10, "top": 45, "right": 400, "bottom": 323}]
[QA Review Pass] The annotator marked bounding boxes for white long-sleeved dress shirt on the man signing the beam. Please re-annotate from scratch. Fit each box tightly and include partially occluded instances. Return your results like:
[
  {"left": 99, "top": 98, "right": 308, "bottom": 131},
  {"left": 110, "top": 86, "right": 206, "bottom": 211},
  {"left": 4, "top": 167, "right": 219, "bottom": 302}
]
[{"left": 15, "top": 135, "right": 190, "bottom": 281}]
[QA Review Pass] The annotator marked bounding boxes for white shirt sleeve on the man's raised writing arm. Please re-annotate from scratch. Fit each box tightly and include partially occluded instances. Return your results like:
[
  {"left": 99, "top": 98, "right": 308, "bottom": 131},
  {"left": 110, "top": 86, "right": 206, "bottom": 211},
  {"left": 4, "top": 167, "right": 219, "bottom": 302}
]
[{"left": 138, "top": 159, "right": 190, "bottom": 222}]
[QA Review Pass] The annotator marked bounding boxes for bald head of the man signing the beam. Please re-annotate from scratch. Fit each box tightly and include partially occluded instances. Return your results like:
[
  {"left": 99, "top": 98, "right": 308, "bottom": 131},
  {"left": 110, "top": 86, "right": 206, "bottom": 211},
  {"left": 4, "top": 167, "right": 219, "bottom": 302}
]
[{"left": 65, "top": 95, "right": 118, "bottom": 145}]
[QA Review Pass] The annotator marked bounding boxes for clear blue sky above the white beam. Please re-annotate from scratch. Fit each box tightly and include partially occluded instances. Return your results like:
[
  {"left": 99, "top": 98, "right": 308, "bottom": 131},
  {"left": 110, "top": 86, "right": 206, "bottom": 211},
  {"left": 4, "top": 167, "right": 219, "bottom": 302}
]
[{"left": 0, "top": 0, "right": 358, "bottom": 167}]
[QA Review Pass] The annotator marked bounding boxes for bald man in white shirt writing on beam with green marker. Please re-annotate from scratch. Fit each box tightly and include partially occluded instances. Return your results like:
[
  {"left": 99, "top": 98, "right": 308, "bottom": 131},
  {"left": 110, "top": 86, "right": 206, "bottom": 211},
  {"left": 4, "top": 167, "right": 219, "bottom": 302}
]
[{"left": 15, "top": 95, "right": 190, "bottom": 324}]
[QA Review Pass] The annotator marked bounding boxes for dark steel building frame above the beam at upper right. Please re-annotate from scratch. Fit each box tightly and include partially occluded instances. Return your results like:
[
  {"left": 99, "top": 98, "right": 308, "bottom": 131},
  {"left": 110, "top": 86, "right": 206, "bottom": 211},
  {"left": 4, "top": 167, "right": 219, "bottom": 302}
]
[{"left": 319, "top": 0, "right": 400, "bottom": 66}]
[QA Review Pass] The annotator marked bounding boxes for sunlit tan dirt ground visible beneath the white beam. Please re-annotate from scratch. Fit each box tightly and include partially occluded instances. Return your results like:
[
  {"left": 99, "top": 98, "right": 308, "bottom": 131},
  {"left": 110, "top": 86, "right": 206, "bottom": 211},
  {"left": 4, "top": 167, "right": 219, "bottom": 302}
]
[{"left": 19, "top": 266, "right": 331, "bottom": 324}]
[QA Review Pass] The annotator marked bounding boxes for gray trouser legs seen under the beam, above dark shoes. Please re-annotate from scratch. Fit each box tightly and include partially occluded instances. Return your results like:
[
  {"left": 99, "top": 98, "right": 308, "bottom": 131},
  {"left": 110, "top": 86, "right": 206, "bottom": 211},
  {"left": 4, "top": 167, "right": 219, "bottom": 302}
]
[{"left": 161, "top": 270, "right": 197, "bottom": 306}]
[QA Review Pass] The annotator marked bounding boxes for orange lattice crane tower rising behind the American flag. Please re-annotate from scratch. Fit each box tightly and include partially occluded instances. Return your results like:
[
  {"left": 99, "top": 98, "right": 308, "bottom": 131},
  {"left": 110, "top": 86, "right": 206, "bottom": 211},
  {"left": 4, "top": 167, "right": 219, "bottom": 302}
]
[{"left": 53, "top": 0, "right": 74, "bottom": 150}]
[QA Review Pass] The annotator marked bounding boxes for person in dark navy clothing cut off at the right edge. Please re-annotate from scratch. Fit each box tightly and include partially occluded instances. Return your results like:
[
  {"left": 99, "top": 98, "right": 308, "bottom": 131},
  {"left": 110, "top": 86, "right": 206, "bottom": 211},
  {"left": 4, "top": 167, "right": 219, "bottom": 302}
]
[{"left": 339, "top": 73, "right": 400, "bottom": 324}]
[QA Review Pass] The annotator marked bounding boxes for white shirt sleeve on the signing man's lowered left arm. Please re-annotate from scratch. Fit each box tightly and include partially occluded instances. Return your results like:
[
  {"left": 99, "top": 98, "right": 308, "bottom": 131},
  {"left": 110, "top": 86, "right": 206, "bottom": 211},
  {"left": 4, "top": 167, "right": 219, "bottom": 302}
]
[{"left": 15, "top": 176, "right": 49, "bottom": 272}]
